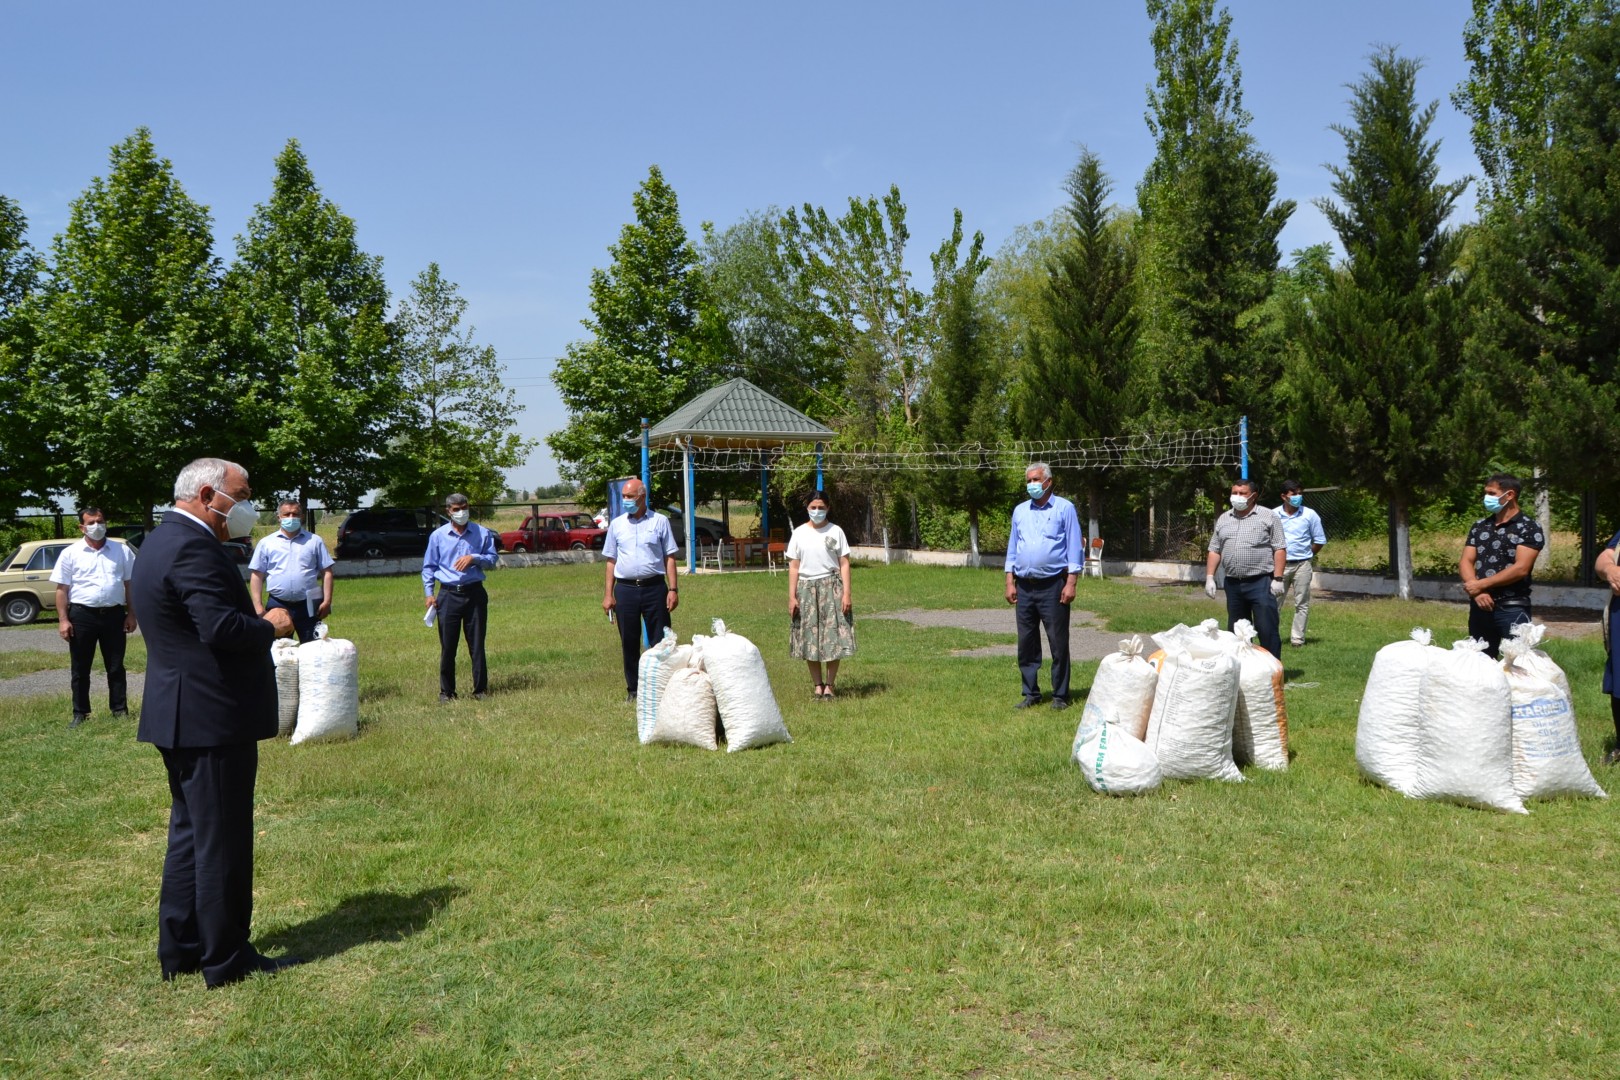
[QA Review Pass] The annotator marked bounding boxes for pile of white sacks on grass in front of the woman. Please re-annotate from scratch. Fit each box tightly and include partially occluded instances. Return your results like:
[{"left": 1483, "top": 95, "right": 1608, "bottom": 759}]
[{"left": 635, "top": 619, "right": 792, "bottom": 751}]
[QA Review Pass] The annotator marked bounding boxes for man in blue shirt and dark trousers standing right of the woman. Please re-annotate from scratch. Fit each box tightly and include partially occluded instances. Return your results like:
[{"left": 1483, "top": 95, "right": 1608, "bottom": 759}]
[{"left": 1006, "top": 461, "right": 1085, "bottom": 709}]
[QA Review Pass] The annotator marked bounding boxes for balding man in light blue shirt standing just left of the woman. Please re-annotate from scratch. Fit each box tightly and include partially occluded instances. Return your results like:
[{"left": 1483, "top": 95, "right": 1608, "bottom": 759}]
[{"left": 603, "top": 479, "right": 680, "bottom": 701}]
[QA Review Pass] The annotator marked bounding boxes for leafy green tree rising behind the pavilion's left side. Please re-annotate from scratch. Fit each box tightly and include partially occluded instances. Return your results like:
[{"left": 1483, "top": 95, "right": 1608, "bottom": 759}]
[{"left": 546, "top": 165, "right": 726, "bottom": 502}]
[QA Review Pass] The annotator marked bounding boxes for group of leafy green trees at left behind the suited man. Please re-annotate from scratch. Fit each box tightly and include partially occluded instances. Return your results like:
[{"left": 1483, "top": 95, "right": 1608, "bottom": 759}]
[{"left": 0, "top": 128, "right": 531, "bottom": 520}]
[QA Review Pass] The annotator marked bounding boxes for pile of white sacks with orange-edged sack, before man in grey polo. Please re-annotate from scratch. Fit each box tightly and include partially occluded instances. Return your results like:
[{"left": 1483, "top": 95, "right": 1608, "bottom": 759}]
[{"left": 1072, "top": 619, "right": 1288, "bottom": 795}]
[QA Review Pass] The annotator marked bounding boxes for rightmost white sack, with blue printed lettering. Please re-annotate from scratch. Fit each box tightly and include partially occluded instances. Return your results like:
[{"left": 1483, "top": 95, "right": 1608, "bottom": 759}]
[{"left": 1502, "top": 623, "right": 1607, "bottom": 798}]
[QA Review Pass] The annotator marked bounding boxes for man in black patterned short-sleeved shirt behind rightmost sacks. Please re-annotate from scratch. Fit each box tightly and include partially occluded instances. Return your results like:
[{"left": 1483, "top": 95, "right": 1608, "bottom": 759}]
[{"left": 1458, "top": 473, "right": 1547, "bottom": 659}]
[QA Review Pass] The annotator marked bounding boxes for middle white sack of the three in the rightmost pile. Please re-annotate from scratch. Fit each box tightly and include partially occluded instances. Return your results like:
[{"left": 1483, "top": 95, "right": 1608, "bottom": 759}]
[{"left": 1411, "top": 638, "right": 1529, "bottom": 814}]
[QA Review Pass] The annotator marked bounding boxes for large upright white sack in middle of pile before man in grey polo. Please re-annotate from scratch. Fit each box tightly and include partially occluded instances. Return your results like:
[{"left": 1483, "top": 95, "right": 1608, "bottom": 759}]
[{"left": 1144, "top": 620, "right": 1243, "bottom": 780}]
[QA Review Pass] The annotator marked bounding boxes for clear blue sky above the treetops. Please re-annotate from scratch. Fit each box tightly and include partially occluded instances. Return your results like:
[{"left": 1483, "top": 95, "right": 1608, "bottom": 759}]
[{"left": 0, "top": 0, "right": 1477, "bottom": 487}]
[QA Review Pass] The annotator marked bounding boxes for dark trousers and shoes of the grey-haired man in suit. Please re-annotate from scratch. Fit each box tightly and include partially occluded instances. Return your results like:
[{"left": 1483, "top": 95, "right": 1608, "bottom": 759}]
[{"left": 157, "top": 743, "right": 261, "bottom": 986}]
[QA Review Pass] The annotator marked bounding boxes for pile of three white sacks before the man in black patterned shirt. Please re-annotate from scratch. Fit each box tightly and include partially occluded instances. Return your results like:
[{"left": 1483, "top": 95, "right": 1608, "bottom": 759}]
[{"left": 1356, "top": 623, "right": 1605, "bottom": 814}]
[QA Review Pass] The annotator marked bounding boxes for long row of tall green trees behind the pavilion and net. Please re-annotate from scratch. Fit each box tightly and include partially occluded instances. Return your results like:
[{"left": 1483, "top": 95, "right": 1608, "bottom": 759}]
[{"left": 548, "top": 0, "right": 1620, "bottom": 594}]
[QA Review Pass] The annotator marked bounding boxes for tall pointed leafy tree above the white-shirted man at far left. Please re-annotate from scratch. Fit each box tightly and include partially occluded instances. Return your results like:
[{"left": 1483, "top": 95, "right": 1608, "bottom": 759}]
[{"left": 26, "top": 128, "right": 231, "bottom": 518}]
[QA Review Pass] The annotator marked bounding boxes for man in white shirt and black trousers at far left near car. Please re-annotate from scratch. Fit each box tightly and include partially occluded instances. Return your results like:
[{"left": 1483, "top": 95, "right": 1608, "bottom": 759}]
[{"left": 50, "top": 507, "right": 134, "bottom": 727}]
